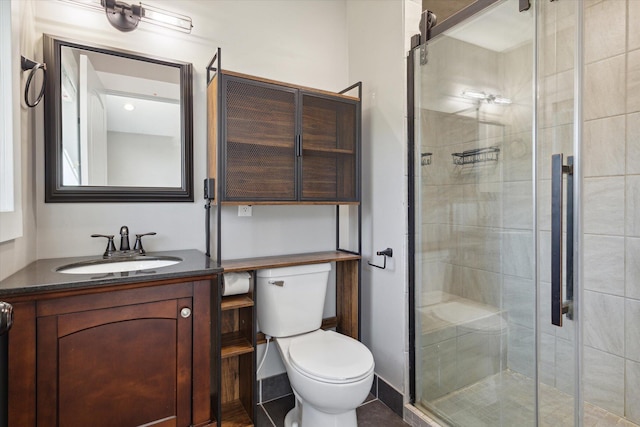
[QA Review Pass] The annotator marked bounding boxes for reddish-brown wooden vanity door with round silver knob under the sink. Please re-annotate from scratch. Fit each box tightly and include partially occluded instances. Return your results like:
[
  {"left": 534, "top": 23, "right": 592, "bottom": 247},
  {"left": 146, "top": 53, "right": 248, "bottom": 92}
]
[{"left": 37, "top": 290, "right": 193, "bottom": 427}]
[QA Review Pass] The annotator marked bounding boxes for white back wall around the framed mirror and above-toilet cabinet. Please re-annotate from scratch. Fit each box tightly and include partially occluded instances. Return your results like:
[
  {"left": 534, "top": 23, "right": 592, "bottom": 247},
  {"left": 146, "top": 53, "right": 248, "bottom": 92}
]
[{"left": 35, "top": 0, "right": 350, "bottom": 258}]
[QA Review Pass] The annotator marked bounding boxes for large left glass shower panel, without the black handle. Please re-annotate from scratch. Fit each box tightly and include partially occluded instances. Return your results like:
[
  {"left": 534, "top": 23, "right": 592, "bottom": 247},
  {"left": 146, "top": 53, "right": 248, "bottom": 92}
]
[{"left": 414, "top": 0, "right": 538, "bottom": 426}]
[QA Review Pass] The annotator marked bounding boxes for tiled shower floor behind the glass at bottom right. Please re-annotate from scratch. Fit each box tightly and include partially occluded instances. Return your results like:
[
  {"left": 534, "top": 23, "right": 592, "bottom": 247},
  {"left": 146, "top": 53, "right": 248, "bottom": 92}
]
[{"left": 416, "top": 370, "right": 640, "bottom": 427}]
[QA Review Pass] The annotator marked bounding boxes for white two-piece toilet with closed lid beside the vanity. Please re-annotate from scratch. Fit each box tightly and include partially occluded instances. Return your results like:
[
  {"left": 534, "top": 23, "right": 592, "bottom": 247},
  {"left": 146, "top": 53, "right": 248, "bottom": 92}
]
[{"left": 257, "top": 264, "right": 374, "bottom": 427}]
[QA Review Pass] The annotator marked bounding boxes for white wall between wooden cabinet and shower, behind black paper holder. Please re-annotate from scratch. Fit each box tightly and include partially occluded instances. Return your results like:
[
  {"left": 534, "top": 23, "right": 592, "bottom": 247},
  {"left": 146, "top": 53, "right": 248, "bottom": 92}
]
[{"left": 347, "top": 0, "right": 408, "bottom": 393}]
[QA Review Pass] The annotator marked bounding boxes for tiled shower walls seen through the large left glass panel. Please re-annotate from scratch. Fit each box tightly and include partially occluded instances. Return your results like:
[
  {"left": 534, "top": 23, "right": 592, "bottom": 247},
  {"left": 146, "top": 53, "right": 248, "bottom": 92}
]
[{"left": 419, "top": 30, "right": 535, "bottom": 400}]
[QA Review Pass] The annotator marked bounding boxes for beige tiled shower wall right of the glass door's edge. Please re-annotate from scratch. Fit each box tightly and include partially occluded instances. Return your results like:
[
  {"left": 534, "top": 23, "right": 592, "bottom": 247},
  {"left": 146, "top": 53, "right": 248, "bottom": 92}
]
[{"left": 584, "top": 0, "right": 640, "bottom": 423}]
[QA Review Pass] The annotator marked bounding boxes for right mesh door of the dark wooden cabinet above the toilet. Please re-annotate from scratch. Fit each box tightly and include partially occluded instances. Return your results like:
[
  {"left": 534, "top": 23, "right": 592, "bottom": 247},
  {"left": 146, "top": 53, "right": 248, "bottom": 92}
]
[{"left": 300, "top": 92, "right": 358, "bottom": 202}]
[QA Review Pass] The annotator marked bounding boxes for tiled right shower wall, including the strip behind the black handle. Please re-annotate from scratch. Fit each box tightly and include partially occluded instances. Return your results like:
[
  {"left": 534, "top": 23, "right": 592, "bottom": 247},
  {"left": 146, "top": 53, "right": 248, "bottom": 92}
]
[{"left": 539, "top": 0, "right": 640, "bottom": 423}]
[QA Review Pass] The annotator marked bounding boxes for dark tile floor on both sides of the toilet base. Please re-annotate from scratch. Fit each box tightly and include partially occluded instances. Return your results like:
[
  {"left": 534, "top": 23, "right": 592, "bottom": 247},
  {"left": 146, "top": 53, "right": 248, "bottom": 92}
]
[{"left": 256, "top": 394, "right": 408, "bottom": 427}]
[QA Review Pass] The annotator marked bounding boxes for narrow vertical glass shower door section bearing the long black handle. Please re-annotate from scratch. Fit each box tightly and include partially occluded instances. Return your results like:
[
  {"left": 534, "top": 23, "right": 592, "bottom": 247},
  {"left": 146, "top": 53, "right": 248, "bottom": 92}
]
[{"left": 536, "top": 2, "right": 582, "bottom": 427}]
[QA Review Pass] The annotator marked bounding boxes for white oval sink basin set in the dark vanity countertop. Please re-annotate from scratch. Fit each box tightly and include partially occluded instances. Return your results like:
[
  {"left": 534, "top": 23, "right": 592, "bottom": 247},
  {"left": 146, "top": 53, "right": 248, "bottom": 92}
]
[{"left": 56, "top": 256, "right": 182, "bottom": 274}]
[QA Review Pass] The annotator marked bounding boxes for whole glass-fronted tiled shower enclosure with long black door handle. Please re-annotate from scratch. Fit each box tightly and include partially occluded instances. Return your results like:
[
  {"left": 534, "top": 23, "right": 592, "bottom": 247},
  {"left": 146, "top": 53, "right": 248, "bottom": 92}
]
[{"left": 408, "top": 0, "right": 640, "bottom": 426}]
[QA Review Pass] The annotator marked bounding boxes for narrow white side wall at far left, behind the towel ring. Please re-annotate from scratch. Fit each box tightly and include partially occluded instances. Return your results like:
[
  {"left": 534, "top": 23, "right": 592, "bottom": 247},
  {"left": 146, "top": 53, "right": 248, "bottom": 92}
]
[{"left": 0, "top": 0, "right": 37, "bottom": 280}]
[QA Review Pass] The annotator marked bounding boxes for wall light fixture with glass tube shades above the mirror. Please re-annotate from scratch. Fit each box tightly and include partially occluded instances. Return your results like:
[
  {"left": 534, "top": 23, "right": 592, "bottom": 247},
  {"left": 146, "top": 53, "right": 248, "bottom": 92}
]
[{"left": 61, "top": 0, "right": 193, "bottom": 33}]
